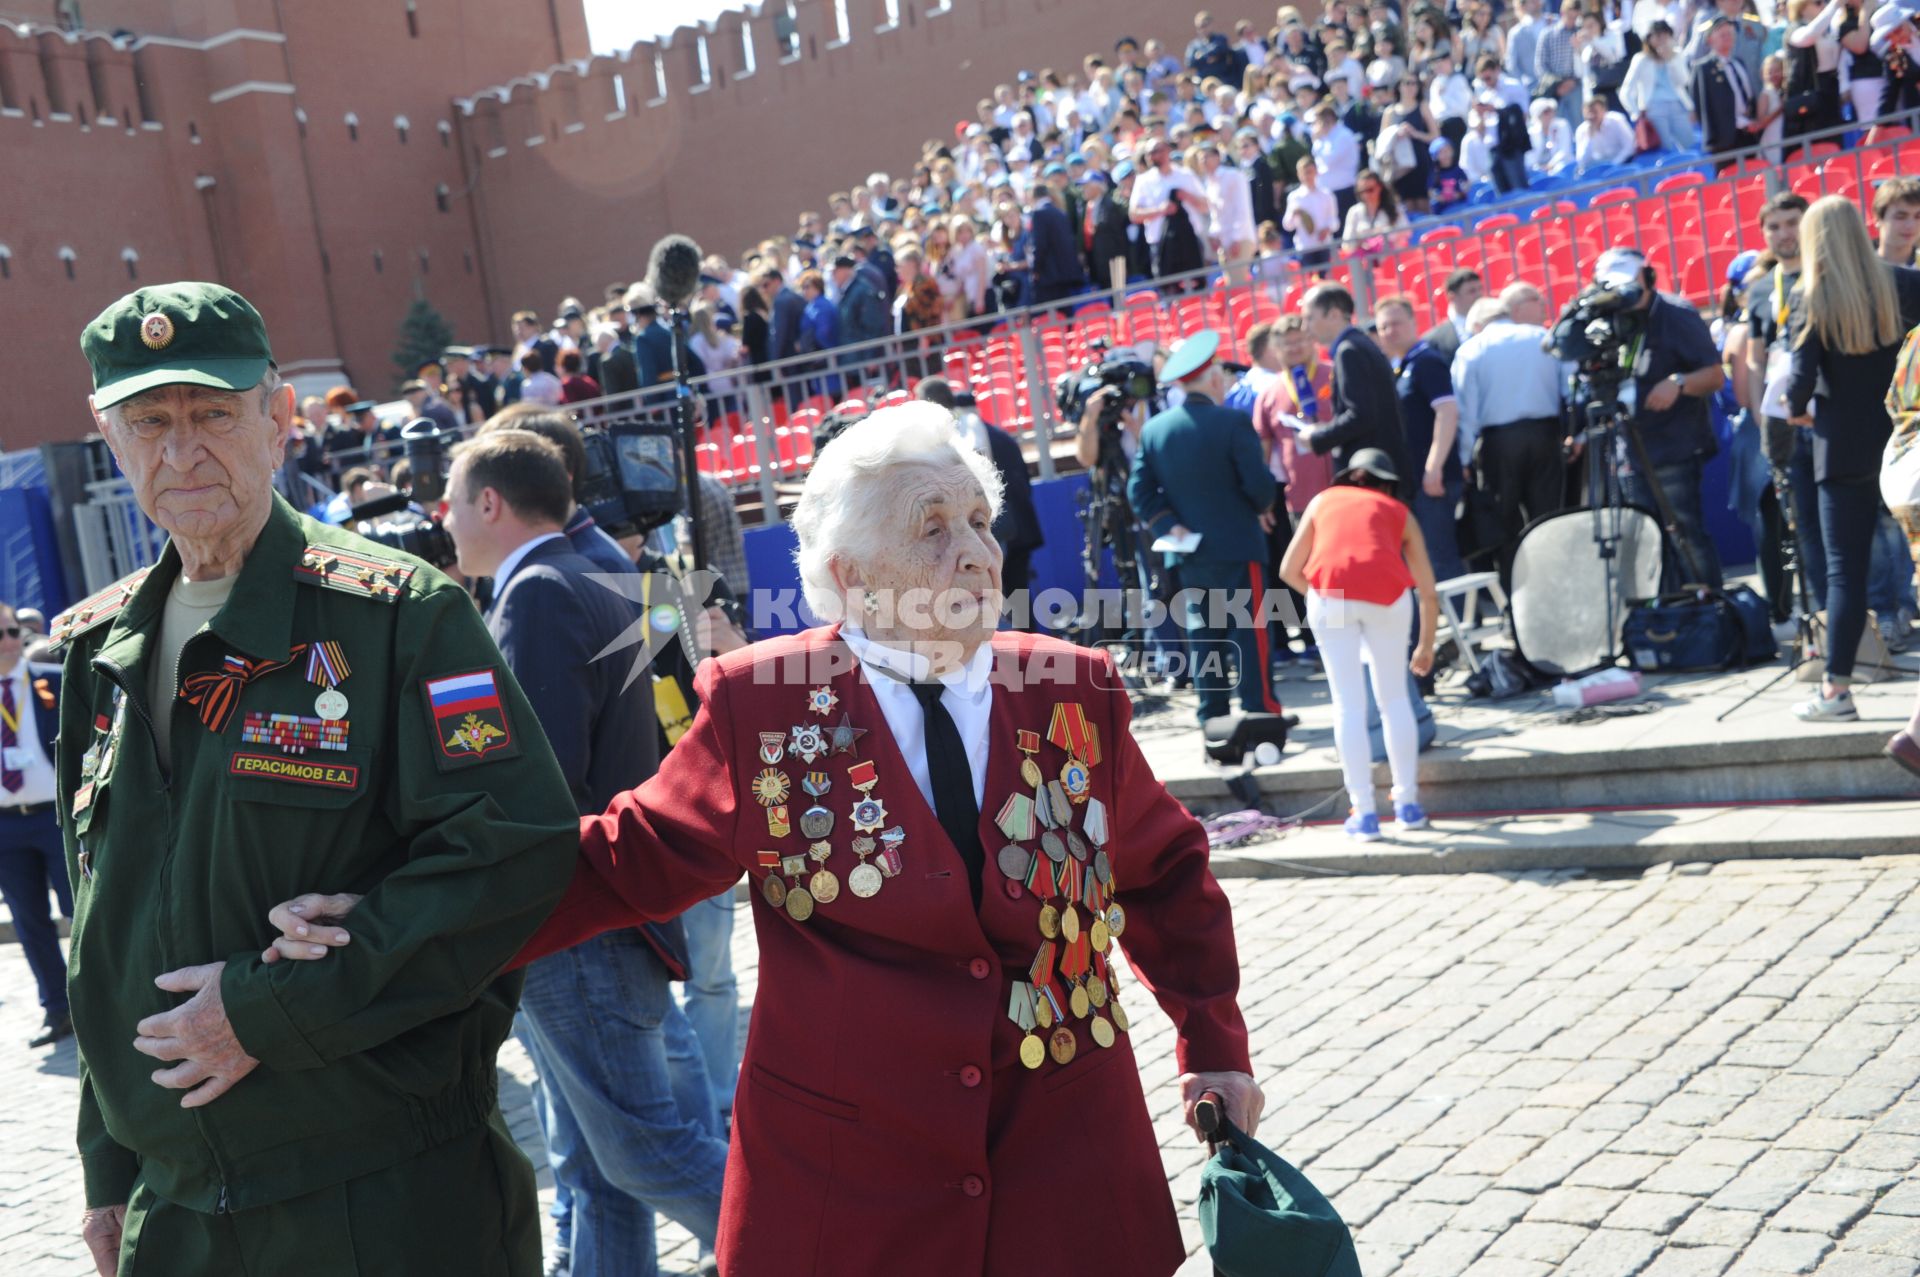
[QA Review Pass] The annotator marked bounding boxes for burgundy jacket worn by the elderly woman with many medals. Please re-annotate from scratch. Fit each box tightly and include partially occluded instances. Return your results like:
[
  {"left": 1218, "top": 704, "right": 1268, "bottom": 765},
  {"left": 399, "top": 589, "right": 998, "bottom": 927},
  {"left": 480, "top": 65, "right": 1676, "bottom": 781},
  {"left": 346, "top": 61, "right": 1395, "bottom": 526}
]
[{"left": 520, "top": 630, "right": 1252, "bottom": 1277}]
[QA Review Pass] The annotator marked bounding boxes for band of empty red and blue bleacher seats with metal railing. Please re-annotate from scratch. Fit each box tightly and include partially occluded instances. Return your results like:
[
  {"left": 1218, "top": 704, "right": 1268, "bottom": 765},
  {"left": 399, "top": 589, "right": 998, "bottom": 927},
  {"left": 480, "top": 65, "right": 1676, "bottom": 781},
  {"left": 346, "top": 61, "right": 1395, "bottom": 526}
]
[{"left": 576, "top": 110, "right": 1920, "bottom": 518}]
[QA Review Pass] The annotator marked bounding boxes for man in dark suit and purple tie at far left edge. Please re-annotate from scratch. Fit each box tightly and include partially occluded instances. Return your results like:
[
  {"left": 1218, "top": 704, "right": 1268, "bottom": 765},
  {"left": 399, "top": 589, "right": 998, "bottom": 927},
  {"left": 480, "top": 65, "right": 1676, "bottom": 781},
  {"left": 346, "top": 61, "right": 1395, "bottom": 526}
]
[{"left": 0, "top": 603, "right": 73, "bottom": 1047}]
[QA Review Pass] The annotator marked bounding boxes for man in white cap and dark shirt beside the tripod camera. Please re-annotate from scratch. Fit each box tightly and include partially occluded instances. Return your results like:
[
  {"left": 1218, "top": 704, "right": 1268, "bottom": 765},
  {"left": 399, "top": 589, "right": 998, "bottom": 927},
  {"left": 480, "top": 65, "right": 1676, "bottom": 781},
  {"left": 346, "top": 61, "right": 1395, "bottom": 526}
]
[{"left": 1569, "top": 248, "right": 1726, "bottom": 593}]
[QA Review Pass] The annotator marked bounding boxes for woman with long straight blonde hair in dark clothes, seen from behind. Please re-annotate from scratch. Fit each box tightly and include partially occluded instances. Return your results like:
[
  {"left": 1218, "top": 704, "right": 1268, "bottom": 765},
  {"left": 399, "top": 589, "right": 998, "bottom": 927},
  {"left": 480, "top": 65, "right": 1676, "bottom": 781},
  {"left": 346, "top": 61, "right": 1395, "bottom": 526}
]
[{"left": 1788, "top": 196, "right": 1920, "bottom": 722}]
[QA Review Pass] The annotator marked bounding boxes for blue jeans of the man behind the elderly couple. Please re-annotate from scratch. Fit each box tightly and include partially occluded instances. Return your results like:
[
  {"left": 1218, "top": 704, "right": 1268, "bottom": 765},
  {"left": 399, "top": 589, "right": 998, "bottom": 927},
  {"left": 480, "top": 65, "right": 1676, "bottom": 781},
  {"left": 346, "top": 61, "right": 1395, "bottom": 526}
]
[{"left": 518, "top": 929, "right": 726, "bottom": 1277}]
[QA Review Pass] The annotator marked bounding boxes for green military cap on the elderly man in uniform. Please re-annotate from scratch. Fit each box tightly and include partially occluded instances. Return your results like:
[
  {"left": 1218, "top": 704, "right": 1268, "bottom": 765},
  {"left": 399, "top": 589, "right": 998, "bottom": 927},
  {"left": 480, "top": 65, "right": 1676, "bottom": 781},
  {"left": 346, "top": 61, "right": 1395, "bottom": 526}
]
[{"left": 81, "top": 284, "right": 273, "bottom": 407}]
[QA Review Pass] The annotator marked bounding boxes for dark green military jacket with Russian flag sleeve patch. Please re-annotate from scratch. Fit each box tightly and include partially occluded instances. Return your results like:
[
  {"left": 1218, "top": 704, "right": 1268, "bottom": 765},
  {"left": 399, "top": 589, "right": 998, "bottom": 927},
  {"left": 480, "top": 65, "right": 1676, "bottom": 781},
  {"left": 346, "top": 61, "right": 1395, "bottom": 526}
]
[{"left": 54, "top": 497, "right": 578, "bottom": 1212}]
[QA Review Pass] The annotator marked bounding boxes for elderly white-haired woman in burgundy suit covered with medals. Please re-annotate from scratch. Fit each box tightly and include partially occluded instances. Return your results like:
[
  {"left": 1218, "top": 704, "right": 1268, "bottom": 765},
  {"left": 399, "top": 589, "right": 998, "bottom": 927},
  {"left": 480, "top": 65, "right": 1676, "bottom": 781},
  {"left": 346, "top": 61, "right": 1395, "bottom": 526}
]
[{"left": 275, "top": 403, "right": 1263, "bottom": 1277}]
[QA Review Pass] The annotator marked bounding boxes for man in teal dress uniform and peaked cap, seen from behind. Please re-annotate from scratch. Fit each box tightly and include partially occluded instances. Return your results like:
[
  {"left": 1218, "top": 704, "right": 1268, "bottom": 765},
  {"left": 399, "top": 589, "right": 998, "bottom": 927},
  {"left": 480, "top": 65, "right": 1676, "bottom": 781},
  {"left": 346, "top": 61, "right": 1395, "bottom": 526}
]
[{"left": 1127, "top": 328, "right": 1281, "bottom": 724}]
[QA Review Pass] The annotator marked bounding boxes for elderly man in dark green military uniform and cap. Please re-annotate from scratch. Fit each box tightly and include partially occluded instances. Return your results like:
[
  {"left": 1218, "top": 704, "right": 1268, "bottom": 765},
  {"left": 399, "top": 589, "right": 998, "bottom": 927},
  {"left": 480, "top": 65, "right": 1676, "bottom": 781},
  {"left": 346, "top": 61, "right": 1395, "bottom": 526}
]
[{"left": 54, "top": 284, "right": 578, "bottom": 1277}]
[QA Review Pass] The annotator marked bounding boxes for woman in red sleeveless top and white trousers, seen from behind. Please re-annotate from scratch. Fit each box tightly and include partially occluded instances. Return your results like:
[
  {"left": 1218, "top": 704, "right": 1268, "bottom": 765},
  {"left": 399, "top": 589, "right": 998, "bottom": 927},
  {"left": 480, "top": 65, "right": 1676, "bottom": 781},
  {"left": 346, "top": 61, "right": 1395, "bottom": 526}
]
[{"left": 1281, "top": 447, "right": 1440, "bottom": 843}]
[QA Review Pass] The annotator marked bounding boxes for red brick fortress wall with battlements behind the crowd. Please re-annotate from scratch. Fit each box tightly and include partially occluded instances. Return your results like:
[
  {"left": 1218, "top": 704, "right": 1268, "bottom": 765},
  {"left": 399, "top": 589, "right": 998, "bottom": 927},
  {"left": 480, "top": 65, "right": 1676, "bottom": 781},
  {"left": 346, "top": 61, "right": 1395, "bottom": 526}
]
[{"left": 0, "top": 0, "right": 1190, "bottom": 449}]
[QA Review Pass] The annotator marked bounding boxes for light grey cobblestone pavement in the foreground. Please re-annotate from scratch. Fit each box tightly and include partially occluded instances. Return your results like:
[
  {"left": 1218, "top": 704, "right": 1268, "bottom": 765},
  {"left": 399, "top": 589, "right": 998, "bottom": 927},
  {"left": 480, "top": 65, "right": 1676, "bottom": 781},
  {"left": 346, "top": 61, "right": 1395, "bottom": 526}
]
[{"left": 0, "top": 855, "right": 1920, "bottom": 1277}]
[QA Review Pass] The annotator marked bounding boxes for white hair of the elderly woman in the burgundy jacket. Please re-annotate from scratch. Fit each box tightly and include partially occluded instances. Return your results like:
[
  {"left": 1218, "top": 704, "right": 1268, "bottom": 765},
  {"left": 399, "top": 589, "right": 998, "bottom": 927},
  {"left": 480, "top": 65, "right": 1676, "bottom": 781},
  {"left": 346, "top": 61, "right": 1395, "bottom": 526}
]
[{"left": 793, "top": 401, "right": 1002, "bottom": 624}]
